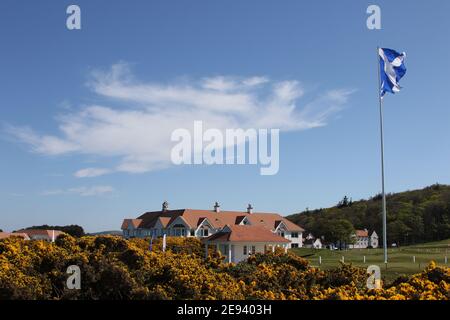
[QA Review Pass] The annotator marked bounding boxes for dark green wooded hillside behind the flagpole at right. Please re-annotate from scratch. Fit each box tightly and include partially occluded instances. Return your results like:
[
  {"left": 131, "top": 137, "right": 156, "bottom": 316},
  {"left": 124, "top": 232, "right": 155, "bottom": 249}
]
[{"left": 287, "top": 184, "right": 450, "bottom": 245}]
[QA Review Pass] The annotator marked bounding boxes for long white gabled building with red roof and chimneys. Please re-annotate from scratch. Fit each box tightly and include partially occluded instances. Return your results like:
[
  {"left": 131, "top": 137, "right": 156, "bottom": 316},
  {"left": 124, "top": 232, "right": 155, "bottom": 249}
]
[{"left": 121, "top": 202, "right": 304, "bottom": 248}]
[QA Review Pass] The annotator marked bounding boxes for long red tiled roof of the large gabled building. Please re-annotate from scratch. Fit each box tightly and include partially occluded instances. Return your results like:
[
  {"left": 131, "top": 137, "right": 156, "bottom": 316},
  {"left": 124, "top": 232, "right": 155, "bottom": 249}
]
[{"left": 122, "top": 209, "right": 304, "bottom": 232}]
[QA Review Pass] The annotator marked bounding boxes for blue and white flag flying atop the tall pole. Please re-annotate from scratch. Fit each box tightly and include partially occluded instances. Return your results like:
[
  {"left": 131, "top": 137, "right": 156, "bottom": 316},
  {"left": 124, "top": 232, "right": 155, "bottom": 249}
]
[{"left": 378, "top": 48, "right": 406, "bottom": 97}]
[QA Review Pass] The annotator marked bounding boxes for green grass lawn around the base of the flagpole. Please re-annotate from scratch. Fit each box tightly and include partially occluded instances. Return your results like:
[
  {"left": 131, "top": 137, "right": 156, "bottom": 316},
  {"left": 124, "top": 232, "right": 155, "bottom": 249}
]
[{"left": 291, "top": 239, "right": 450, "bottom": 281}]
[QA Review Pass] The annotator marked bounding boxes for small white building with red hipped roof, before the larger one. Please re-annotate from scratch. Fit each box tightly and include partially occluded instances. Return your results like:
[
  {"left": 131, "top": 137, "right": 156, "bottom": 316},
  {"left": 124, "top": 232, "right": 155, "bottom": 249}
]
[{"left": 202, "top": 225, "right": 290, "bottom": 263}]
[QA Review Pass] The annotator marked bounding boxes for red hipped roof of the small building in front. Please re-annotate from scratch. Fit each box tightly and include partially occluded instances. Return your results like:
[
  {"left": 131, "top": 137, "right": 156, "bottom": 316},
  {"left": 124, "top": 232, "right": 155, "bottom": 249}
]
[{"left": 203, "top": 225, "right": 290, "bottom": 243}]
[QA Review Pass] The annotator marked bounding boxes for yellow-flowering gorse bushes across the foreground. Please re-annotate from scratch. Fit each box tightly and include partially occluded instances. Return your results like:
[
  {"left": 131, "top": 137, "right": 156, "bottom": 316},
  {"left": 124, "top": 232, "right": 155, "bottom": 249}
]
[{"left": 0, "top": 235, "right": 450, "bottom": 300}]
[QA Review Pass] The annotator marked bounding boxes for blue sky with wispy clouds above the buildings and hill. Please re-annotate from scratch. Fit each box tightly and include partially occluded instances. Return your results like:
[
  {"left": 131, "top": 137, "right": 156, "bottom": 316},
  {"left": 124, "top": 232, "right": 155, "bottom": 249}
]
[{"left": 0, "top": 0, "right": 450, "bottom": 231}]
